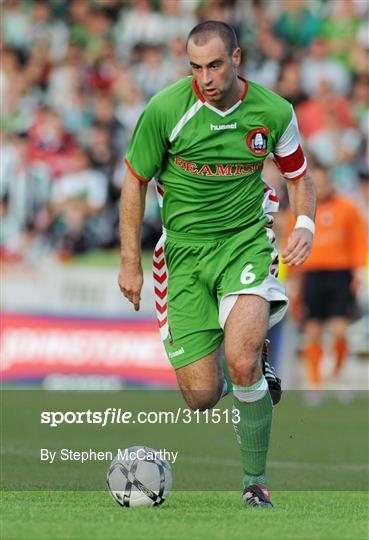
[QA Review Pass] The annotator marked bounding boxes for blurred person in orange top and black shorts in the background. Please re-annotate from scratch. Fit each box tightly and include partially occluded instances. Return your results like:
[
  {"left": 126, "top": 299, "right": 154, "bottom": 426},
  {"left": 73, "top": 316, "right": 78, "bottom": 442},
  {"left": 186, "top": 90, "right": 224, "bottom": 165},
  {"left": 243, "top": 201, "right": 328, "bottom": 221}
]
[{"left": 289, "top": 162, "right": 367, "bottom": 389}]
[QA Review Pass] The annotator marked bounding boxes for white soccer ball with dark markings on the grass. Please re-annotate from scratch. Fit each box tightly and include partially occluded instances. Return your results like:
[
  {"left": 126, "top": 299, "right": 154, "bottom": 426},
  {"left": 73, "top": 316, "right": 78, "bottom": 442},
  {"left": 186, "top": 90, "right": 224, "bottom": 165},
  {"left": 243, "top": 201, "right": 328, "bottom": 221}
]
[{"left": 106, "top": 446, "right": 172, "bottom": 507}]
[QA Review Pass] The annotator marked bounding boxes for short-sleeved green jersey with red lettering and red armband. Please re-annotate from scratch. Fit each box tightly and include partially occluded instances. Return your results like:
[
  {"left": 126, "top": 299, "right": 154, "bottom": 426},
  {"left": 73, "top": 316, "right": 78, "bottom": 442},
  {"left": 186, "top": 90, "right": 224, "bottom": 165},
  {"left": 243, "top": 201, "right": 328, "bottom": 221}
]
[{"left": 126, "top": 77, "right": 306, "bottom": 235}]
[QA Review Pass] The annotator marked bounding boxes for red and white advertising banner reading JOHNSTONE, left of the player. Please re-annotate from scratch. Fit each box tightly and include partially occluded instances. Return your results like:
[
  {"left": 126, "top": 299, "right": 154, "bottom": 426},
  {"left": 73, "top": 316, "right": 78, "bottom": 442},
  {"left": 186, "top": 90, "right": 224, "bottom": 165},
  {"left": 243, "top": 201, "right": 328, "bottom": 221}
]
[{"left": 0, "top": 313, "right": 176, "bottom": 386}]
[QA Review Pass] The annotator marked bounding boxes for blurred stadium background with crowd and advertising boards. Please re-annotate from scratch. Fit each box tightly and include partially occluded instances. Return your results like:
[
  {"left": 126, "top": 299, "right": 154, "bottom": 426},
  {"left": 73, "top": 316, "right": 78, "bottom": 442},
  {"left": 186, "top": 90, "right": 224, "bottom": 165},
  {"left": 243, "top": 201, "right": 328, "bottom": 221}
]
[{"left": 0, "top": 0, "right": 369, "bottom": 389}]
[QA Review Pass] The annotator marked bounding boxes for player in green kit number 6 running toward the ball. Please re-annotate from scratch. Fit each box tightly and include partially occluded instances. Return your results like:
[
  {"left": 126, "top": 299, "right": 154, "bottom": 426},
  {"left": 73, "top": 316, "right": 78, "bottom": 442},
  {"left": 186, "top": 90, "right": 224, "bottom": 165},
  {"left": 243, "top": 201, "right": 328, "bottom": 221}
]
[{"left": 119, "top": 21, "right": 315, "bottom": 507}]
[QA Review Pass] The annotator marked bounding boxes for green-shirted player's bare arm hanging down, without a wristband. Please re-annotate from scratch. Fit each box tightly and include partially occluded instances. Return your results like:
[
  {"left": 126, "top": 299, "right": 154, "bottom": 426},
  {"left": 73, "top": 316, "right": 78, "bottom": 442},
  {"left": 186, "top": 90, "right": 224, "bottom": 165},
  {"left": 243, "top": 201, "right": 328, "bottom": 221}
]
[{"left": 118, "top": 169, "right": 147, "bottom": 311}]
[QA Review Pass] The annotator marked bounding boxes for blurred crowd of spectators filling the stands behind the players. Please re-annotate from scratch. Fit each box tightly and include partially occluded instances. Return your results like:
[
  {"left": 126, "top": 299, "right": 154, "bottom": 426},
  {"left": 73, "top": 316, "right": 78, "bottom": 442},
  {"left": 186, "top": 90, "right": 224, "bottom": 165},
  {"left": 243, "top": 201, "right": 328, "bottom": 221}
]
[{"left": 0, "top": 0, "right": 369, "bottom": 260}]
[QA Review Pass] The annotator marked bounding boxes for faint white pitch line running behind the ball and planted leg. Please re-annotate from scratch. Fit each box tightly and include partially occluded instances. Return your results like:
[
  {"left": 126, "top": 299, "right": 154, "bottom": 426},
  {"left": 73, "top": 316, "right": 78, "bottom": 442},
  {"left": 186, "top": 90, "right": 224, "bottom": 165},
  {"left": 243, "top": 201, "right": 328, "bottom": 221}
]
[{"left": 0, "top": 446, "right": 369, "bottom": 472}]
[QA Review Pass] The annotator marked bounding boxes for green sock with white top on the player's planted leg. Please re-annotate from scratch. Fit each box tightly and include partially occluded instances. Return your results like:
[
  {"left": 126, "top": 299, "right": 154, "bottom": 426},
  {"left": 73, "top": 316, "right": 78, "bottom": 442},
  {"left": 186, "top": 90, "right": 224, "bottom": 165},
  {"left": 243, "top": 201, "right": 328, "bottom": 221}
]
[{"left": 233, "top": 377, "right": 273, "bottom": 487}]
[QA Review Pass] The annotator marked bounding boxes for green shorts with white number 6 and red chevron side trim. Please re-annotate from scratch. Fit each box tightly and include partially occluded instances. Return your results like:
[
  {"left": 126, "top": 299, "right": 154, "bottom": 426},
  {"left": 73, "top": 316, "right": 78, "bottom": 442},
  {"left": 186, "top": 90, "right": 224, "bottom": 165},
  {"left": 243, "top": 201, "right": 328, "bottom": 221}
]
[{"left": 153, "top": 220, "right": 287, "bottom": 368}]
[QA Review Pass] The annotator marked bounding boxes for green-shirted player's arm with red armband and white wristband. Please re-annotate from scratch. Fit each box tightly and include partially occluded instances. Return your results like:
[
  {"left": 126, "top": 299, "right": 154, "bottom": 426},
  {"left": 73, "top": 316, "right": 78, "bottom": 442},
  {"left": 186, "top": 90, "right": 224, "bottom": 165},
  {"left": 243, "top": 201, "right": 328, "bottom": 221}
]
[{"left": 274, "top": 105, "right": 316, "bottom": 266}]
